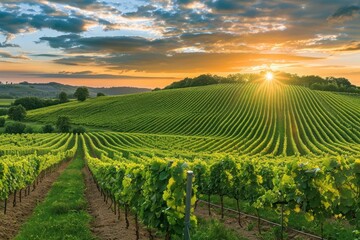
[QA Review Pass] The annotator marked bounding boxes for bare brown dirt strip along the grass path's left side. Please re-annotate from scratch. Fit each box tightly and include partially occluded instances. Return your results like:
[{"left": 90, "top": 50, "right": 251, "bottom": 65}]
[{"left": 0, "top": 161, "right": 69, "bottom": 240}]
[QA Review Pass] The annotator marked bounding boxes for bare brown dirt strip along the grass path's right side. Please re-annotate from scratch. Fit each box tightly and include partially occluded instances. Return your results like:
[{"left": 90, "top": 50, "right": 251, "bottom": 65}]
[{"left": 83, "top": 168, "right": 149, "bottom": 240}]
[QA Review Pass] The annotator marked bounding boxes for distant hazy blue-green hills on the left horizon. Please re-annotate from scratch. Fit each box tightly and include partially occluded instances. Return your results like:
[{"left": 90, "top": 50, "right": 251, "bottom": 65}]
[{"left": 0, "top": 82, "right": 150, "bottom": 98}]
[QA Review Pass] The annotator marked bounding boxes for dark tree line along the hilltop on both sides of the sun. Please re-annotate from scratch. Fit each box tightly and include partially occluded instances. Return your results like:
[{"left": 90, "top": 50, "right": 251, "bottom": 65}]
[{"left": 164, "top": 72, "right": 360, "bottom": 93}]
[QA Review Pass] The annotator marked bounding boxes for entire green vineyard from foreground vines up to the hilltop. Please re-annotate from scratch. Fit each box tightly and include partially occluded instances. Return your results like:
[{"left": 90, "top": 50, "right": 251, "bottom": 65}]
[{"left": 0, "top": 83, "right": 360, "bottom": 240}]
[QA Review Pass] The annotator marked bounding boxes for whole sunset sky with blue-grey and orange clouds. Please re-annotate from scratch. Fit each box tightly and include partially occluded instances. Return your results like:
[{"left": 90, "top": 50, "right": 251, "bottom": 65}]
[{"left": 0, "top": 0, "right": 360, "bottom": 88}]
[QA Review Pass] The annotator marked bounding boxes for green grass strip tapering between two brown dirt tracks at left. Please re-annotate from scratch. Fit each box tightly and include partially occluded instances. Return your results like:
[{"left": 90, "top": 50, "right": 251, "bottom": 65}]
[{"left": 15, "top": 144, "right": 95, "bottom": 240}]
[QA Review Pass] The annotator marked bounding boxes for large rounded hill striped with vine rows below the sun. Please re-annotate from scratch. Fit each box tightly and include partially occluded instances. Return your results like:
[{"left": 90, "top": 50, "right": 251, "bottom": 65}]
[{"left": 28, "top": 83, "right": 360, "bottom": 155}]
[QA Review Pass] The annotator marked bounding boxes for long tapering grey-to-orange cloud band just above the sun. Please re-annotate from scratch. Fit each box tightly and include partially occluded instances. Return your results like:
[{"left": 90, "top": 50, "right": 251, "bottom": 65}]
[{"left": 54, "top": 53, "right": 317, "bottom": 73}]
